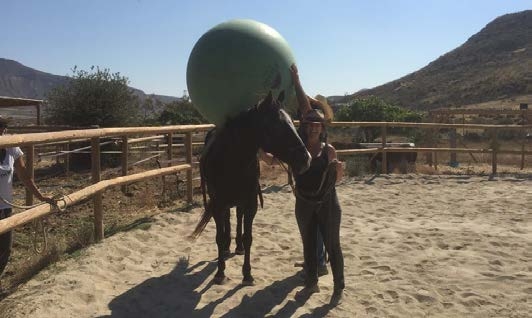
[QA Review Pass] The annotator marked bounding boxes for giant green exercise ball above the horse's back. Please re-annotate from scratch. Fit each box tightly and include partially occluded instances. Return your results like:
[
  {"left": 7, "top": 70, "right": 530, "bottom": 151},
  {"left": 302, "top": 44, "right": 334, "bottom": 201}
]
[{"left": 187, "top": 19, "right": 295, "bottom": 125}]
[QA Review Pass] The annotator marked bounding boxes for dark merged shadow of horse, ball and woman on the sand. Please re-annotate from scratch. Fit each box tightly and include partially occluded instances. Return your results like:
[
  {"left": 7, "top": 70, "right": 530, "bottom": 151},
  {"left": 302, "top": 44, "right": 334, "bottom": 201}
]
[{"left": 100, "top": 258, "right": 329, "bottom": 318}]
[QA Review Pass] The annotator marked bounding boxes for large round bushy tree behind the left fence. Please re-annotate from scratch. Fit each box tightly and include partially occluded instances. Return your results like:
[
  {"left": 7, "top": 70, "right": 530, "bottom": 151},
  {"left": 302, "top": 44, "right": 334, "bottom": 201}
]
[{"left": 45, "top": 66, "right": 140, "bottom": 127}]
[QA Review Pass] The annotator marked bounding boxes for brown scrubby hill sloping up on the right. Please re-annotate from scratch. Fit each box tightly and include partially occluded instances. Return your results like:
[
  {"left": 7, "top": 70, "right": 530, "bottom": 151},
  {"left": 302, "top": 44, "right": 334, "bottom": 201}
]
[{"left": 335, "top": 10, "right": 532, "bottom": 110}]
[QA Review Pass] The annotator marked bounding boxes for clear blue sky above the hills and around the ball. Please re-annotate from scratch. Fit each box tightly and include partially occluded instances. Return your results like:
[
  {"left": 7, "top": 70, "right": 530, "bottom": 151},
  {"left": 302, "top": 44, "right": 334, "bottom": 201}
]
[{"left": 0, "top": 0, "right": 532, "bottom": 96}]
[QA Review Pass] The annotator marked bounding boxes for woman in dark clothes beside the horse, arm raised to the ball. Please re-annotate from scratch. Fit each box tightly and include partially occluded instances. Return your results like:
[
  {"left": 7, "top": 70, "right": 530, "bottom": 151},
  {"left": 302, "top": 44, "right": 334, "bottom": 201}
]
[{"left": 260, "top": 65, "right": 345, "bottom": 305}]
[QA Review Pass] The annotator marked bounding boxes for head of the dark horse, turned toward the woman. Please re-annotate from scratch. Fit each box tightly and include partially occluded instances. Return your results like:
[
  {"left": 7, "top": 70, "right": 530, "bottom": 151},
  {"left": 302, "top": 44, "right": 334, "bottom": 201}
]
[{"left": 256, "top": 92, "right": 312, "bottom": 174}]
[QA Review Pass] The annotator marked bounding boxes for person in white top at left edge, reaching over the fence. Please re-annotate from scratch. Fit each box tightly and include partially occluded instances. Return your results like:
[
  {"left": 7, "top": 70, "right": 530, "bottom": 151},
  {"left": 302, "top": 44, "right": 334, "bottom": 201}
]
[{"left": 0, "top": 117, "right": 55, "bottom": 274}]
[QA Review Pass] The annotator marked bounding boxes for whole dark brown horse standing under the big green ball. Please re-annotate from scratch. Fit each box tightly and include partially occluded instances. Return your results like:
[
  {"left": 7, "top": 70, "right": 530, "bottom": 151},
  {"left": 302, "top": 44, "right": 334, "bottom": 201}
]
[{"left": 191, "top": 91, "right": 311, "bottom": 286}]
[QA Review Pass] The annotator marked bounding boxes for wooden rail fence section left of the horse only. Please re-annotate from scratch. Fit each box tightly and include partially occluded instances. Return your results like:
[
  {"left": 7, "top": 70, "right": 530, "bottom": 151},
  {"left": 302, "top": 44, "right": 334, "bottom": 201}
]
[{"left": 0, "top": 125, "right": 214, "bottom": 241}]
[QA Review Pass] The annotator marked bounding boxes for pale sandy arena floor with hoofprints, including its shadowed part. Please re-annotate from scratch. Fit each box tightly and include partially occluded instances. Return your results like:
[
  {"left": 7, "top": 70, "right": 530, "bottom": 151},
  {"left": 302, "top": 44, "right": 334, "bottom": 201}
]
[{"left": 0, "top": 174, "right": 532, "bottom": 318}]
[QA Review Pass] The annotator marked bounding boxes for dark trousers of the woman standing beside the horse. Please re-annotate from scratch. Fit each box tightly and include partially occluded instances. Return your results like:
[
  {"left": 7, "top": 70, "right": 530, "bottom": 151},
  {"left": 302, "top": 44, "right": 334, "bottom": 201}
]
[{"left": 296, "top": 189, "right": 345, "bottom": 290}]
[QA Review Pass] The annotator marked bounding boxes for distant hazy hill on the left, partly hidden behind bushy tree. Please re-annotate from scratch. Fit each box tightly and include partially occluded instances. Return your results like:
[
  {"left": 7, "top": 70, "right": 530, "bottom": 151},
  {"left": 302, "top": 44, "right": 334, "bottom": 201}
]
[{"left": 0, "top": 58, "right": 179, "bottom": 103}]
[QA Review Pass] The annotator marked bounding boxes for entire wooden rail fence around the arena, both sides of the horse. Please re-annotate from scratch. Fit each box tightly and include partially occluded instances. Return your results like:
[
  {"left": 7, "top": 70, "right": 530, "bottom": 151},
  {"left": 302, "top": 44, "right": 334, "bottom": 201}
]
[{"left": 0, "top": 122, "right": 532, "bottom": 240}]
